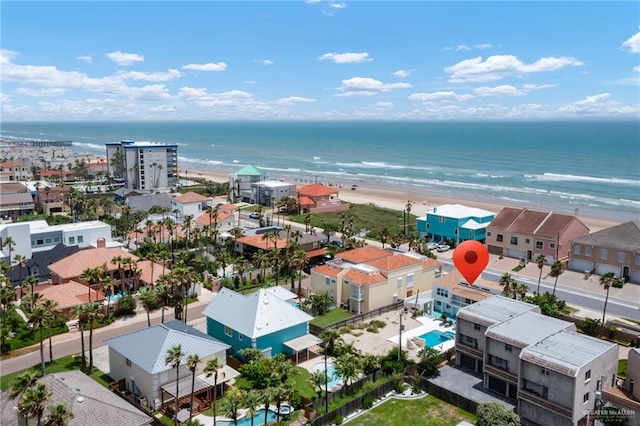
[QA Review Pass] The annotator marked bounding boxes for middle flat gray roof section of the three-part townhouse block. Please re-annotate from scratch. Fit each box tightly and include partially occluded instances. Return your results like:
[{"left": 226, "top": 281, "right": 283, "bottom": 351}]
[{"left": 485, "top": 312, "right": 575, "bottom": 348}]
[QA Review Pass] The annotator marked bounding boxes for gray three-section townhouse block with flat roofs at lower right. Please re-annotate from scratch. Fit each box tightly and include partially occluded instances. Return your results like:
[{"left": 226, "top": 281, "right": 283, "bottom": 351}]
[{"left": 456, "top": 296, "right": 618, "bottom": 426}]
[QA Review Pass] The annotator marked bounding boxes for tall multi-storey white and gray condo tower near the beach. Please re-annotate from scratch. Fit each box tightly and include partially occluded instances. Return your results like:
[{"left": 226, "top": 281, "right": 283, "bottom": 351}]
[{"left": 105, "top": 140, "right": 178, "bottom": 192}]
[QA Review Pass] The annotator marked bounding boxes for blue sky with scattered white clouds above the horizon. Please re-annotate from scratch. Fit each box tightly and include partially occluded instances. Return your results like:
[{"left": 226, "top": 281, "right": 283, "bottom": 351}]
[{"left": 0, "top": 0, "right": 640, "bottom": 121}]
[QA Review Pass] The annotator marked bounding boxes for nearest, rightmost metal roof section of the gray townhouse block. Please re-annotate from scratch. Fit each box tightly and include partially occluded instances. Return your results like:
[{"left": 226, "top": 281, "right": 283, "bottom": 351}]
[{"left": 520, "top": 330, "right": 618, "bottom": 377}]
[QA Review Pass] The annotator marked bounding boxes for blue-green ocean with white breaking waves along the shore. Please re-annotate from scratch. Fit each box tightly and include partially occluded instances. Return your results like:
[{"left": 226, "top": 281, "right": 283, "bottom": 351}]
[{"left": 0, "top": 121, "right": 640, "bottom": 220}]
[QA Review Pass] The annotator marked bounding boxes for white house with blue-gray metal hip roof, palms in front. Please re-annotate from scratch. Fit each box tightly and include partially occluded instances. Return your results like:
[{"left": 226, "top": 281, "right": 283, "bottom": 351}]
[{"left": 105, "top": 320, "right": 239, "bottom": 410}]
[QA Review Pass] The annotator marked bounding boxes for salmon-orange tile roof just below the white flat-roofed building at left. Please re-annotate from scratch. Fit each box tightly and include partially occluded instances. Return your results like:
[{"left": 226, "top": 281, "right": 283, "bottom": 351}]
[{"left": 49, "top": 247, "right": 138, "bottom": 280}]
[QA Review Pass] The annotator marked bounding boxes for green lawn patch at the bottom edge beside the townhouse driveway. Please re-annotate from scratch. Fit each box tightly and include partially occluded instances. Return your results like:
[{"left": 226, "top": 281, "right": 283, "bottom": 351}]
[{"left": 348, "top": 395, "right": 477, "bottom": 426}]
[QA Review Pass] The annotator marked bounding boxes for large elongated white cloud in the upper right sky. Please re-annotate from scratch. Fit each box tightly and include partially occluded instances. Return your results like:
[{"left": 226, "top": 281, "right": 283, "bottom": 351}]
[{"left": 444, "top": 55, "right": 583, "bottom": 83}]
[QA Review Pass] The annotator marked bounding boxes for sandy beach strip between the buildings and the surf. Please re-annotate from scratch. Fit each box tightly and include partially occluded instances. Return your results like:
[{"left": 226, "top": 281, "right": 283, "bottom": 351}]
[{"left": 179, "top": 168, "right": 626, "bottom": 232}]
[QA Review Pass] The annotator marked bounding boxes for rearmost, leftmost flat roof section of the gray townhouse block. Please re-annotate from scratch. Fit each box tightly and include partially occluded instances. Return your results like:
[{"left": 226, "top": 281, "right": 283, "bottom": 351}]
[{"left": 458, "top": 296, "right": 538, "bottom": 327}]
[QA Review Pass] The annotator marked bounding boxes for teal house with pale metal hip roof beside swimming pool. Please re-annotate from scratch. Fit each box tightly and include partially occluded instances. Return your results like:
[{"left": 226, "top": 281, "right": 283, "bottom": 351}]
[{"left": 203, "top": 288, "right": 320, "bottom": 358}]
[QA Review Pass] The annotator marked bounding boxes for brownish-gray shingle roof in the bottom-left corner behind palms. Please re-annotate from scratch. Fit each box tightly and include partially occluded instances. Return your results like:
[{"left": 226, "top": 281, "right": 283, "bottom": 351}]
[{"left": 0, "top": 370, "right": 153, "bottom": 426}]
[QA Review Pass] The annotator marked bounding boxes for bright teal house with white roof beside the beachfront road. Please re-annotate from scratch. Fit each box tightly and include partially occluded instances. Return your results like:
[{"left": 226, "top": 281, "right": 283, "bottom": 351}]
[{"left": 417, "top": 204, "right": 496, "bottom": 245}]
